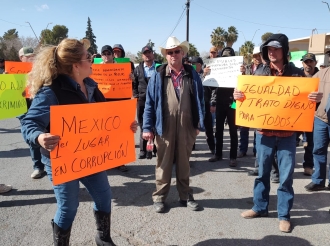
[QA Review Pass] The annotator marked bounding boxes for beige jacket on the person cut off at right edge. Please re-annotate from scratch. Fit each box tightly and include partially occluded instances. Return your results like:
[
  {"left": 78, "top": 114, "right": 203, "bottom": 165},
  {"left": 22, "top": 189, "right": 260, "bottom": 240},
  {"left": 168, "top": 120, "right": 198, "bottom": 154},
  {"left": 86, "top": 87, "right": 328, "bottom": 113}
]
[{"left": 313, "top": 67, "right": 330, "bottom": 123}]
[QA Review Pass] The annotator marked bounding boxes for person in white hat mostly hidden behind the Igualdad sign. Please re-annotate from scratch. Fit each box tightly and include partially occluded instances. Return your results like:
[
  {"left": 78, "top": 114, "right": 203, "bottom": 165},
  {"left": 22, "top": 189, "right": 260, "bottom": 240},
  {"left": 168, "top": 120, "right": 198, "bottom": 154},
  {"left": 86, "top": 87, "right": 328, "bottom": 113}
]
[{"left": 237, "top": 46, "right": 262, "bottom": 158}]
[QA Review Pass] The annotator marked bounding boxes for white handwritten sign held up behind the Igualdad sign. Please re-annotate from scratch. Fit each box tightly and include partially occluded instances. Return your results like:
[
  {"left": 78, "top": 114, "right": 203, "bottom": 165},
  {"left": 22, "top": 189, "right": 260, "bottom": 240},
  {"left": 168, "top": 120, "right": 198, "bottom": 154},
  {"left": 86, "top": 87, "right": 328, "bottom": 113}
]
[{"left": 203, "top": 56, "right": 243, "bottom": 88}]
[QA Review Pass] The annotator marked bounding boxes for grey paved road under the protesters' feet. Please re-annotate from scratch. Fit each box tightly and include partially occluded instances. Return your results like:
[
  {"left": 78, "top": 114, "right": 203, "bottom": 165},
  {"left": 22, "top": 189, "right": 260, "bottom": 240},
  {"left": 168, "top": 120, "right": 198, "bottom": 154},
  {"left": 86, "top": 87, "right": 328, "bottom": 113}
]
[{"left": 0, "top": 119, "right": 330, "bottom": 246}]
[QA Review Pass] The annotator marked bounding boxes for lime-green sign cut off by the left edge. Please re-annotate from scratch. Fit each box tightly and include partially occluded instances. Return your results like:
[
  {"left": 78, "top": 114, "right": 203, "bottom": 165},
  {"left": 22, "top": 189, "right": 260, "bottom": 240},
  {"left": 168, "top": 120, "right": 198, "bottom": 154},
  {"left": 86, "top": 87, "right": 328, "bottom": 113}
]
[{"left": 0, "top": 74, "right": 27, "bottom": 119}]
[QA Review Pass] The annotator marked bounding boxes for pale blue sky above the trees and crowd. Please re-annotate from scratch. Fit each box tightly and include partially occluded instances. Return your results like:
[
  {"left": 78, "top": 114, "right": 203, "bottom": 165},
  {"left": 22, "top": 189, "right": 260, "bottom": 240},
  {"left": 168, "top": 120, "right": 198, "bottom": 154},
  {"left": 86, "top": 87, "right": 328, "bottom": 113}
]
[{"left": 0, "top": 0, "right": 330, "bottom": 54}]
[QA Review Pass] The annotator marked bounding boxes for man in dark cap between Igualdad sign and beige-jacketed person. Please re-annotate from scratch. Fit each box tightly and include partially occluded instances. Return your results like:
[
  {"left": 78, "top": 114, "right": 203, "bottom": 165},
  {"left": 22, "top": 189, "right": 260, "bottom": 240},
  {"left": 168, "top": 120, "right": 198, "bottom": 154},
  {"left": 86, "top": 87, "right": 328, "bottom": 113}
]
[{"left": 301, "top": 53, "right": 319, "bottom": 176}]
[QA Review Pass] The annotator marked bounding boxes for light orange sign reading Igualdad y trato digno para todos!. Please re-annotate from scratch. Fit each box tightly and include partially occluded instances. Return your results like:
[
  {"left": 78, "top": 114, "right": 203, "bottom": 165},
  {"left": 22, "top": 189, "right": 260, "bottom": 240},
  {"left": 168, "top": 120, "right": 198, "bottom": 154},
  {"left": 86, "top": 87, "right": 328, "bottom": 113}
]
[{"left": 236, "top": 75, "right": 319, "bottom": 132}]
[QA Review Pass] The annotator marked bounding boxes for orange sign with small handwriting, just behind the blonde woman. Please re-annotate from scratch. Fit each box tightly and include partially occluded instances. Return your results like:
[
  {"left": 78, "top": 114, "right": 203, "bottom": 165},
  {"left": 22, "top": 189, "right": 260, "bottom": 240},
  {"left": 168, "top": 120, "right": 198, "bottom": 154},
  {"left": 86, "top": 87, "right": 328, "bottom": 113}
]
[{"left": 90, "top": 63, "right": 132, "bottom": 98}]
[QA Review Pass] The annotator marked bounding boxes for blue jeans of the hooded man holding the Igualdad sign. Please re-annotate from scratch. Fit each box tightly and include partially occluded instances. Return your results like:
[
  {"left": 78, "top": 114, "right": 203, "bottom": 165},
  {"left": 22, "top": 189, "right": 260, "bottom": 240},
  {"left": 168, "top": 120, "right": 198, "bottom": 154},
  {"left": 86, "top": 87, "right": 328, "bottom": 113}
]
[{"left": 252, "top": 132, "right": 296, "bottom": 220}]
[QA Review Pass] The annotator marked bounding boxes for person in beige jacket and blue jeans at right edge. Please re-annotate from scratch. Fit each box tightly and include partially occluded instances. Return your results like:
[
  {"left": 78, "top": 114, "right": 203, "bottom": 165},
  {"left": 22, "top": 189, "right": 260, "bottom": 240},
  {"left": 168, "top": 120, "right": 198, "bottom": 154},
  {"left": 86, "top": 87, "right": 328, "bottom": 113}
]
[{"left": 305, "top": 52, "right": 330, "bottom": 191}]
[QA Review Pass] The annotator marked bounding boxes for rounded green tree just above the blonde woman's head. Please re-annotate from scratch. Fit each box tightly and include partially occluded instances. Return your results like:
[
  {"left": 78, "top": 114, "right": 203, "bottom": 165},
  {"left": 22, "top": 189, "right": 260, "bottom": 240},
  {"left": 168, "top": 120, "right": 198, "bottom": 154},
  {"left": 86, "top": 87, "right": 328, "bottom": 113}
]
[{"left": 40, "top": 25, "right": 69, "bottom": 45}]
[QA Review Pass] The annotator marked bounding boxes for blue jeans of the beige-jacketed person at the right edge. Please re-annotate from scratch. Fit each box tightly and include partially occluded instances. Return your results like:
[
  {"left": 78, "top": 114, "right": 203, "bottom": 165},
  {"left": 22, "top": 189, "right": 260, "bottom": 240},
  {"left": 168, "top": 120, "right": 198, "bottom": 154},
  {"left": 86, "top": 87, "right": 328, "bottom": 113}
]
[{"left": 312, "top": 117, "right": 330, "bottom": 185}]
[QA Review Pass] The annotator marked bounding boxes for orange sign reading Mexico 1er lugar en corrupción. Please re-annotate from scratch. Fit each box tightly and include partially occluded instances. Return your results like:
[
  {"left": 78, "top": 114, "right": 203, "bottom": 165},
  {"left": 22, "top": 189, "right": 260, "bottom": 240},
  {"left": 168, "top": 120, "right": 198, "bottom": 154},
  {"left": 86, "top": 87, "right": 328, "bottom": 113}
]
[{"left": 50, "top": 99, "right": 136, "bottom": 185}]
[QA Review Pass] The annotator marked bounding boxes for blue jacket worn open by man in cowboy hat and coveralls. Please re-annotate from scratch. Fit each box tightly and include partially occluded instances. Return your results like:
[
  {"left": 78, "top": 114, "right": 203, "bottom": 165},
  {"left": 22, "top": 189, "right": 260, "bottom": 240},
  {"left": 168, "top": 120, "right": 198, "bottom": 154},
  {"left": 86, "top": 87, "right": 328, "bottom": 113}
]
[{"left": 142, "top": 64, "right": 205, "bottom": 136}]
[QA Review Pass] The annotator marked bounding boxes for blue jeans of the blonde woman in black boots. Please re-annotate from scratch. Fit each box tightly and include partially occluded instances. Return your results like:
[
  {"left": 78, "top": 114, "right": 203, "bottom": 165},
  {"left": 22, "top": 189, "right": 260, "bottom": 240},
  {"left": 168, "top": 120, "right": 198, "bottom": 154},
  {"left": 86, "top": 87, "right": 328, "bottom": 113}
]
[{"left": 45, "top": 165, "right": 111, "bottom": 230}]
